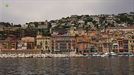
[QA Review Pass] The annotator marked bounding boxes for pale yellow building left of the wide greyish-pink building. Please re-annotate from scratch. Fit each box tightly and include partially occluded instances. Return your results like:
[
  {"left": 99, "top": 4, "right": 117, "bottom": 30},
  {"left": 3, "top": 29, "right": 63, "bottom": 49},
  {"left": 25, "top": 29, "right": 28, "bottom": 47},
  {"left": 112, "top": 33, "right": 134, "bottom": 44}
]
[{"left": 36, "top": 35, "right": 51, "bottom": 52}]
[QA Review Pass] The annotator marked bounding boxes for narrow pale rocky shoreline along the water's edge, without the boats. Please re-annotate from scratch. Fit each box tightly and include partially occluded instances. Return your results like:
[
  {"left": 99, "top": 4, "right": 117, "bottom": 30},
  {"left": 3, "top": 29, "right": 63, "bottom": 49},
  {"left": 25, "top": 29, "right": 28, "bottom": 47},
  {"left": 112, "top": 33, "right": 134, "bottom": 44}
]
[{"left": 0, "top": 54, "right": 134, "bottom": 58}]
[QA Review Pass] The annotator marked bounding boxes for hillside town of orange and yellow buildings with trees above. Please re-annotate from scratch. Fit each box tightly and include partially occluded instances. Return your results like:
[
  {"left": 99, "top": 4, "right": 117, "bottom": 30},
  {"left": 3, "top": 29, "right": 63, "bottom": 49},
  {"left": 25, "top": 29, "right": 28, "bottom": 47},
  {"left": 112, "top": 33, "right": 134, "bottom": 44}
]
[{"left": 0, "top": 12, "right": 134, "bottom": 55}]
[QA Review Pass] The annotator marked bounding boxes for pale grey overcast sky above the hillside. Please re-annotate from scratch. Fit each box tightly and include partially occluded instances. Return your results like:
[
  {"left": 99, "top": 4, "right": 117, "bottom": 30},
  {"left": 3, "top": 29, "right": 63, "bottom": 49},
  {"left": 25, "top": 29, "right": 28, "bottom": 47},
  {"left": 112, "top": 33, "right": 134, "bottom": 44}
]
[{"left": 0, "top": 0, "right": 134, "bottom": 24}]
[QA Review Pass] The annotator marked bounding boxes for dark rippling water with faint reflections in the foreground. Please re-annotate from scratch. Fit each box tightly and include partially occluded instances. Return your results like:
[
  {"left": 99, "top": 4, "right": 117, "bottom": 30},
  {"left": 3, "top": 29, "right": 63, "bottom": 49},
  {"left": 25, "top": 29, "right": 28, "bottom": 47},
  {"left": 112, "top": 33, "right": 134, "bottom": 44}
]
[{"left": 0, "top": 57, "right": 134, "bottom": 75}]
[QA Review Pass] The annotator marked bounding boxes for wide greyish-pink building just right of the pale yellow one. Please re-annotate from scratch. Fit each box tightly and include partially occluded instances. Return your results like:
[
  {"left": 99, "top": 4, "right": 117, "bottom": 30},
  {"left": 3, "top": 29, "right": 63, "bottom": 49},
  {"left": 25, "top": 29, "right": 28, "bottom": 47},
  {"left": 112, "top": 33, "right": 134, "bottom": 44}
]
[{"left": 52, "top": 35, "right": 76, "bottom": 52}]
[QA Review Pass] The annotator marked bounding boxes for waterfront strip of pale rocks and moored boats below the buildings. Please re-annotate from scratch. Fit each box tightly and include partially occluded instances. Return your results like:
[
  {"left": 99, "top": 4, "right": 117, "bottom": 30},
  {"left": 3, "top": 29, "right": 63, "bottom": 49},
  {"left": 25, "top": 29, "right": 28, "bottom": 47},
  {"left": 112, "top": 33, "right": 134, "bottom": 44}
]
[{"left": 0, "top": 53, "right": 134, "bottom": 58}]
